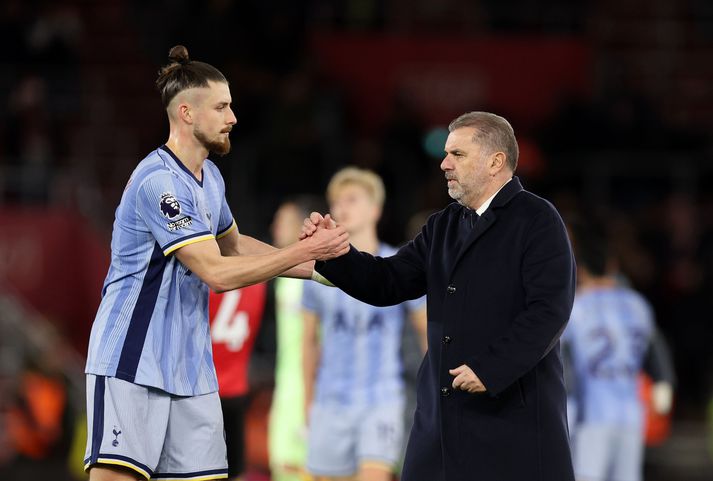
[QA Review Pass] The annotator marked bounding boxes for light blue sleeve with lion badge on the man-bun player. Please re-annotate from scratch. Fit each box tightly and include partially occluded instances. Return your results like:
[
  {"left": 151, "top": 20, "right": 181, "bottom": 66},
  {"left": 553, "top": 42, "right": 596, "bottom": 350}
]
[{"left": 136, "top": 173, "right": 215, "bottom": 256}]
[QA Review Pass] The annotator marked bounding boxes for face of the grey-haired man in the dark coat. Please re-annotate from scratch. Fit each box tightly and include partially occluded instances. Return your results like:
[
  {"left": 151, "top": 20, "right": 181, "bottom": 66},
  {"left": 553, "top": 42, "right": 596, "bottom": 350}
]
[{"left": 441, "top": 127, "right": 490, "bottom": 209}]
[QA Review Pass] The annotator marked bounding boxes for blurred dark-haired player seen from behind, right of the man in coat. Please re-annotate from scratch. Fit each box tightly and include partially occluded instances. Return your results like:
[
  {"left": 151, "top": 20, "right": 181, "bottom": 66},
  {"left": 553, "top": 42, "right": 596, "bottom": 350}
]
[{"left": 562, "top": 220, "right": 673, "bottom": 481}]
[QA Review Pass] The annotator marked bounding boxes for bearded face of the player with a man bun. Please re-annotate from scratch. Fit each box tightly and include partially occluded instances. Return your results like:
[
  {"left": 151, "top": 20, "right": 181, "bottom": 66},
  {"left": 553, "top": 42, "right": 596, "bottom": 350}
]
[{"left": 193, "top": 82, "right": 237, "bottom": 155}]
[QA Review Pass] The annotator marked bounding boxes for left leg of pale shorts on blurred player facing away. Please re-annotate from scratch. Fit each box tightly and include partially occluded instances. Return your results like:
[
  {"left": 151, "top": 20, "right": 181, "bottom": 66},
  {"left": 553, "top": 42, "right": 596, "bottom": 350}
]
[{"left": 572, "top": 424, "right": 616, "bottom": 481}]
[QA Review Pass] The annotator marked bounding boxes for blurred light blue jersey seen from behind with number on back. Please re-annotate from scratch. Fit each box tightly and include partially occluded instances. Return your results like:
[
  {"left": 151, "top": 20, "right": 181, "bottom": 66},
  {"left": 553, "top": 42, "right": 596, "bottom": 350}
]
[{"left": 562, "top": 287, "right": 654, "bottom": 427}]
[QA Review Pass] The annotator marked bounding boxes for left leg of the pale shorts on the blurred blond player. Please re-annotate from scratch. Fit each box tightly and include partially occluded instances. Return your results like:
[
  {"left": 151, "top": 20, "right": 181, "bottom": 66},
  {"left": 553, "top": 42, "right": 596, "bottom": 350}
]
[{"left": 307, "top": 404, "right": 358, "bottom": 478}]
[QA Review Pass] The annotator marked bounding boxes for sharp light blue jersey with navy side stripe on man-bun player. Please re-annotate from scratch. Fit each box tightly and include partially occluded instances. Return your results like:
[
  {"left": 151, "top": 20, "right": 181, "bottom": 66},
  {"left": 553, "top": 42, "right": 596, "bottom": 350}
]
[{"left": 86, "top": 145, "right": 237, "bottom": 396}]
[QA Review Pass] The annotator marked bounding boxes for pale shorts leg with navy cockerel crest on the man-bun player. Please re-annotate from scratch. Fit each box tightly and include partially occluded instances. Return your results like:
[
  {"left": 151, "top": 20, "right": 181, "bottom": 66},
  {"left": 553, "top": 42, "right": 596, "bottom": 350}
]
[{"left": 84, "top": 374, "right": 170, "bottom": 479}]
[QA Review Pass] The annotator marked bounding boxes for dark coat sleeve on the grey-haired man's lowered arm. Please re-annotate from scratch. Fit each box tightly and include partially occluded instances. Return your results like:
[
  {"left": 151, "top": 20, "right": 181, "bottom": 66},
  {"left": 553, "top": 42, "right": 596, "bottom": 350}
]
[{"left": 466, "top": 207, "right": 576, "bottom": 395}]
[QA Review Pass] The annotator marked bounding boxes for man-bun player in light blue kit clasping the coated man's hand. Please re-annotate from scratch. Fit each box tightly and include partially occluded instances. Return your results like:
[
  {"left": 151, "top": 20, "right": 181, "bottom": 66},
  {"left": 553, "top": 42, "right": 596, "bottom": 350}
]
[{"left": 85, "top": 45, "right": 348, "bottom": 481}]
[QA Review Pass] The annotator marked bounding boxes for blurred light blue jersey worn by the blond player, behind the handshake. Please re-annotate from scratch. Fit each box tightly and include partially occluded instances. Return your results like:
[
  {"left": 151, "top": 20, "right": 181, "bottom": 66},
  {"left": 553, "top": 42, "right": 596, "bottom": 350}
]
[{"left": 302, "top": 244, "right": 426, "bottom": 407}]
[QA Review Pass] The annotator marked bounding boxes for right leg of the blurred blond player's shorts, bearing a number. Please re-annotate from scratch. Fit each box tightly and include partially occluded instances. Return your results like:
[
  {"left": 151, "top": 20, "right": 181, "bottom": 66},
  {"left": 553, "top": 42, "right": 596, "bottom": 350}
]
[{"left": 357, "top": 402, "right": 404, "bottom": 473}]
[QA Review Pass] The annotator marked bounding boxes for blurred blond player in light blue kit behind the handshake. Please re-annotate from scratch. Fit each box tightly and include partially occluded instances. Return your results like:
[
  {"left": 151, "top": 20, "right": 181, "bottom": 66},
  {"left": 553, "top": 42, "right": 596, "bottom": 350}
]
[{"left": 302, "top": 167, "right": 426, "bottom": 481}]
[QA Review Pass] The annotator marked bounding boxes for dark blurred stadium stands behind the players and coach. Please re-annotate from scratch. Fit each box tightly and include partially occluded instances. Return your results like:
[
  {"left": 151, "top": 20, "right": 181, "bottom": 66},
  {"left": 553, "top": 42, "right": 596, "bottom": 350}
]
[{"left": 0, "top": 0, "right": 713, "bottom": 481}]
